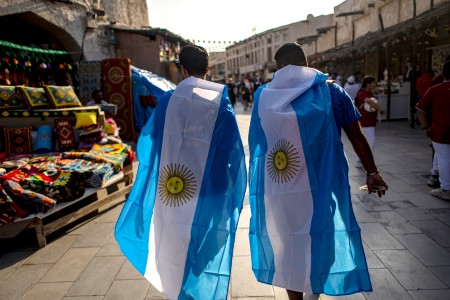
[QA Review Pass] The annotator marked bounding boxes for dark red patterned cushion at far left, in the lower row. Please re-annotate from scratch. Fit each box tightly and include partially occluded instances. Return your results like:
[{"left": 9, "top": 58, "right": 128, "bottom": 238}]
[{"left": 3, "top": 126, "right": 33, "bottom": 154}]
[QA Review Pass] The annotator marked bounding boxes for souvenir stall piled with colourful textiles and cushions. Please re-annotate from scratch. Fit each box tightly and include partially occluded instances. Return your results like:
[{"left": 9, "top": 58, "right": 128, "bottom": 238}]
[{"left": 0, "top": 42, "right": 135, "bottom": 247}]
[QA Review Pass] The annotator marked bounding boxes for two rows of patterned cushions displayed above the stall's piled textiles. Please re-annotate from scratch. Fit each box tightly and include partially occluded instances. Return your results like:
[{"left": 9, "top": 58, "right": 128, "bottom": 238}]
[{"left": 0, "top": 85, "right": 107, "bottom": 155}]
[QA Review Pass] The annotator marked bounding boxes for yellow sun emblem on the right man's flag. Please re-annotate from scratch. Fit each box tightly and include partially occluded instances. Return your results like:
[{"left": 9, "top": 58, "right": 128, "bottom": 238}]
[{"left": 267, "top": 139, "right": 300, "bottom": 183}]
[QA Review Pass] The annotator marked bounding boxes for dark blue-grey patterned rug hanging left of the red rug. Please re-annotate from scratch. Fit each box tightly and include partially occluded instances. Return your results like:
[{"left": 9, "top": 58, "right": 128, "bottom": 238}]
[{"left": 78, "top": 61, "right": 102, "bottom": 104}]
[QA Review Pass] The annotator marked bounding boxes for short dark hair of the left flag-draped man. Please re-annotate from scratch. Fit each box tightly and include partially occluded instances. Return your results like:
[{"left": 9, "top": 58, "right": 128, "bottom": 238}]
[{"left": 179, "top": 45, "right": 209, "bottom": 76}]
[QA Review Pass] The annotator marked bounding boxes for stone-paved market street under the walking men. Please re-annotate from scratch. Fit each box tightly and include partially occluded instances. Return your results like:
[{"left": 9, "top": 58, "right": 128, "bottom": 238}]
[{"left": 0, "top": 104, "right": 450, "bottom": 300}]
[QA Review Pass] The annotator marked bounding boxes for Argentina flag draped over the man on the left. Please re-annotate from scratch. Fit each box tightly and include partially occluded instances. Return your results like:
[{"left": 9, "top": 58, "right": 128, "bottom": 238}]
[{"left": 115, "top": 77, "right": 247, "bottom": 299}]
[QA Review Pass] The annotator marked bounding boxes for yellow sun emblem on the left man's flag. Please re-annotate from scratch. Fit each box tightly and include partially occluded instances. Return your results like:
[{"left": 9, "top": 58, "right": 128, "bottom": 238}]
[{"left": 158, "top": 164, "right": 197, "bottom": 206}]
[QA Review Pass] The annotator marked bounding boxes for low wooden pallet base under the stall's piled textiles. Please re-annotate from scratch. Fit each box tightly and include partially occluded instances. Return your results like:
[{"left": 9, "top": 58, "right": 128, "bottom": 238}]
[{"left": 0, "top": 164, "right": 134, "bottom": 248}]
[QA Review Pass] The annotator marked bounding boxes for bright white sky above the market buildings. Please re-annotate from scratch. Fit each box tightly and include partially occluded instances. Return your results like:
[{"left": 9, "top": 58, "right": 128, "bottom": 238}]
[{"left": 146, "top": 0, "right": 344, "bottom": 48}]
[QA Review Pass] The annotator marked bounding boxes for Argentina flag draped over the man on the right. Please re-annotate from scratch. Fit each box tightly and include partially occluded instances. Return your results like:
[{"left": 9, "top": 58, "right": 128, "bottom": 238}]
[{"left": 249, "top": 65, "right": 372, "bottom": 295}]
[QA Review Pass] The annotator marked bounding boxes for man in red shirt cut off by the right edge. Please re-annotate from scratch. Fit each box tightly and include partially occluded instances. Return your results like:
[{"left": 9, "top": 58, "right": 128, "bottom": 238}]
[{"left": 416, "top": 61, "right": 450, "bottom": 200}]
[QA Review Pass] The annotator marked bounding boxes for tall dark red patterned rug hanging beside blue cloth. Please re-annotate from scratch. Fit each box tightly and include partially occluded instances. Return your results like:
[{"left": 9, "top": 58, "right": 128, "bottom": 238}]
[{"left": 102, "top": 58, "right": 136, "bottom": 141}]
